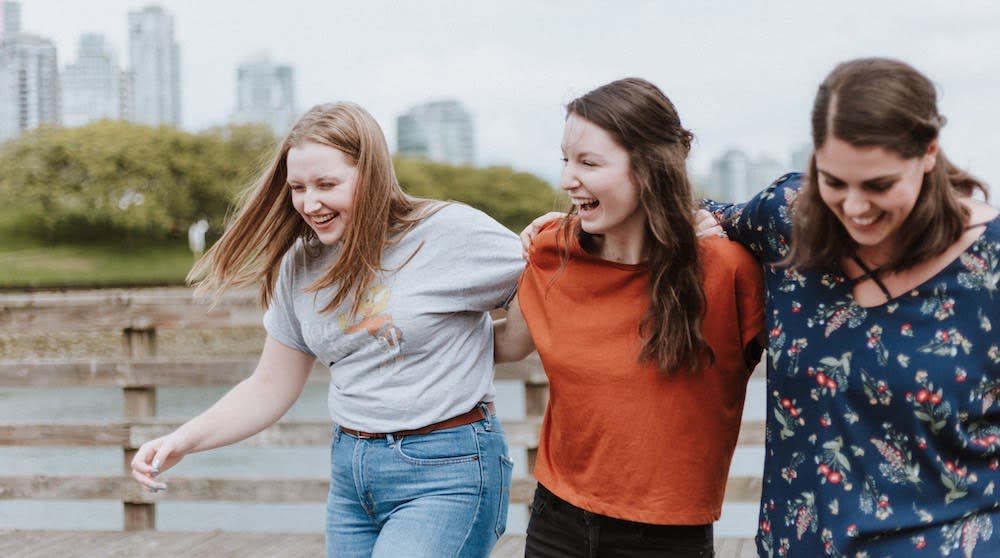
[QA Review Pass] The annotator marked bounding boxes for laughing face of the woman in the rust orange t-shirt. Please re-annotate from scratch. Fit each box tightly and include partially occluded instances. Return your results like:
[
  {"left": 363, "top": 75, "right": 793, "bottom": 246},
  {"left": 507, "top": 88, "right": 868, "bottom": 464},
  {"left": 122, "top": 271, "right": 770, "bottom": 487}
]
[{"left": 560, "top": 113, "right": 646, "bottom": 246}]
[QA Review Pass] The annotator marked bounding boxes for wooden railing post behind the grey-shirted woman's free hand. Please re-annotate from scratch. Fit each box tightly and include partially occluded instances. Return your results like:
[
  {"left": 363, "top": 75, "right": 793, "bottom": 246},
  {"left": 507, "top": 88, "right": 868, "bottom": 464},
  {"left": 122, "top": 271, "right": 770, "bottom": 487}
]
[{"left": 122, "top": 327, "right": 156, "bottom": 531}]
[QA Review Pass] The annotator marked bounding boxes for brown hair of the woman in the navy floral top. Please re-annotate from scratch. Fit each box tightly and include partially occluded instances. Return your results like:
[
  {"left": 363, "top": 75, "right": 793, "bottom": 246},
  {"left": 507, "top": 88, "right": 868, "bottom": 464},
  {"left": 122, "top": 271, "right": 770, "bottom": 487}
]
[{"left": 786, "top": 58, "right": 989, "bottom": 271}]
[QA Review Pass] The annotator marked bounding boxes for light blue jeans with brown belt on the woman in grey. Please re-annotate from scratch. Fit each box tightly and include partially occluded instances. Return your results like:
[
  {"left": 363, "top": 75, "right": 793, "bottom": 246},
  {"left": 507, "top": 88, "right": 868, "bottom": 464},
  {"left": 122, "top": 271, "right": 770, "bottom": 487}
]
[{"left": 326, "top": 406, "right": 513, "bottom": 558}]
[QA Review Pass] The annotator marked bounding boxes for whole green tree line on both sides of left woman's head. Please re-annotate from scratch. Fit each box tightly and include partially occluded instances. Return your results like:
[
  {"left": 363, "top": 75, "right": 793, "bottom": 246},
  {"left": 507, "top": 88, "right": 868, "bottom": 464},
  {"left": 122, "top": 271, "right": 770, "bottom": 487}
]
[{"left": 0, "top": 120, "right": 566, "bottom": 252}]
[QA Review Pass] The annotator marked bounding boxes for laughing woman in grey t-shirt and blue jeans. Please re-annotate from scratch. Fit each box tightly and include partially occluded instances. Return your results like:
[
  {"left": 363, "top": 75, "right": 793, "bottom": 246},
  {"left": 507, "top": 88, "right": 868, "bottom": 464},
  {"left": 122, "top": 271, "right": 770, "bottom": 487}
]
[{"left": 132, "top": 103, "right": 524, "bottom": 558}]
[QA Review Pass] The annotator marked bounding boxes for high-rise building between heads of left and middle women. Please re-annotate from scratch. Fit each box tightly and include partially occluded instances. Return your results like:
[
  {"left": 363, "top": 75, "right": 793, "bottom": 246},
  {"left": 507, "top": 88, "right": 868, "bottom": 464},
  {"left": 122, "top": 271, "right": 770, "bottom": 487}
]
[{"left": 396, "top": 100, "right": 476, "bottom": 165}]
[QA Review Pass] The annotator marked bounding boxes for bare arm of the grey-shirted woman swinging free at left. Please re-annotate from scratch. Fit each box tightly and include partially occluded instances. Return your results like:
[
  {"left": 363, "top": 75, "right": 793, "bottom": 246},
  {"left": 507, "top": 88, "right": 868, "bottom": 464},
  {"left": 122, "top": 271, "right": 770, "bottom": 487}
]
[{"left": 132, "top": 336, "right": 315, "bottom": 491}]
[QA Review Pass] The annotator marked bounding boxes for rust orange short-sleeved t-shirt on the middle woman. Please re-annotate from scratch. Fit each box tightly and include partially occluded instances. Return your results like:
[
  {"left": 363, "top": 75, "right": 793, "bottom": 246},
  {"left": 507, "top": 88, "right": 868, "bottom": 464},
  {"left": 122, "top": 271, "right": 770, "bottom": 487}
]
[{"left": 518, "top": 223, "right": 764, "bottom": 525}]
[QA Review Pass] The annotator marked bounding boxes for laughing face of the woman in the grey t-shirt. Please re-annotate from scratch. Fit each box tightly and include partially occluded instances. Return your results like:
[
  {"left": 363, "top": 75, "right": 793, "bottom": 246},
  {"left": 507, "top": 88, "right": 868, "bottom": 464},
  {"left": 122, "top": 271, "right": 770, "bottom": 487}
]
[{"left": 286, "top": 142, "right": 357, "bottom": 245}]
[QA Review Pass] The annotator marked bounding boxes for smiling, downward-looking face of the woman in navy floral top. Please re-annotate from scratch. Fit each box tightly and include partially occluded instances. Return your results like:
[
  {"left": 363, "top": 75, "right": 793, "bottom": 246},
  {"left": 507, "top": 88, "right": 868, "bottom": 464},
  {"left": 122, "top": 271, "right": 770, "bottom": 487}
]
[{"left": 816, "top": 137, "right": 937, "bottom": 265}]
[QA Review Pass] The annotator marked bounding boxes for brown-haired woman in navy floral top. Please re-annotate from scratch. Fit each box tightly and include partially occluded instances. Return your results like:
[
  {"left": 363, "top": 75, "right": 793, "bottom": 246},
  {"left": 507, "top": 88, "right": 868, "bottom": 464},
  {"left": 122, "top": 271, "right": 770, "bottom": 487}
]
[{"left": 706, "top": 59, "right": 1000, "bottom": 558}]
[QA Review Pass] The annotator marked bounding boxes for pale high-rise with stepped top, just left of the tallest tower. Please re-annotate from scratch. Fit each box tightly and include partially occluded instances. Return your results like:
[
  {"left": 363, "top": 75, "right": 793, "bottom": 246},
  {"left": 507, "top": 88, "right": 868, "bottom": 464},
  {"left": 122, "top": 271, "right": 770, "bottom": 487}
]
[{"left": 62, "top": 34, "right": 122, "bottom": 126}]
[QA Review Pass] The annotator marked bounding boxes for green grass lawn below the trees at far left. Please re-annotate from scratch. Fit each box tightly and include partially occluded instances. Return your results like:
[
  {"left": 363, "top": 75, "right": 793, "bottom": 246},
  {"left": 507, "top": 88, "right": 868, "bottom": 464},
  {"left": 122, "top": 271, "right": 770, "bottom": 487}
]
[{"left": 0, "top": 232, "right": 194, "bottom": 289}]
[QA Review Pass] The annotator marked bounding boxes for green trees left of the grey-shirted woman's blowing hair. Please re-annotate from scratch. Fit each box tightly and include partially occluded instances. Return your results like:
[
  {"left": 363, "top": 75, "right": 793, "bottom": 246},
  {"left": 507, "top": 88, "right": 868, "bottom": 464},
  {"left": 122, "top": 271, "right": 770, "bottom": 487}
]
[{"left": 0, "top": 121, "right": 274, "bottom": 242}]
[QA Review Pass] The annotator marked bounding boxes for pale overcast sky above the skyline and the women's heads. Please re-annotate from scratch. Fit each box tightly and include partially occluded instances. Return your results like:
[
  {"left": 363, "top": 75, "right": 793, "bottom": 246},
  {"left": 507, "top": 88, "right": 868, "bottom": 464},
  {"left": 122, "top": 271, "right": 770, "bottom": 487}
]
[{"left": 13, "top": 0, "right": 1000, "bottom": 195}]
